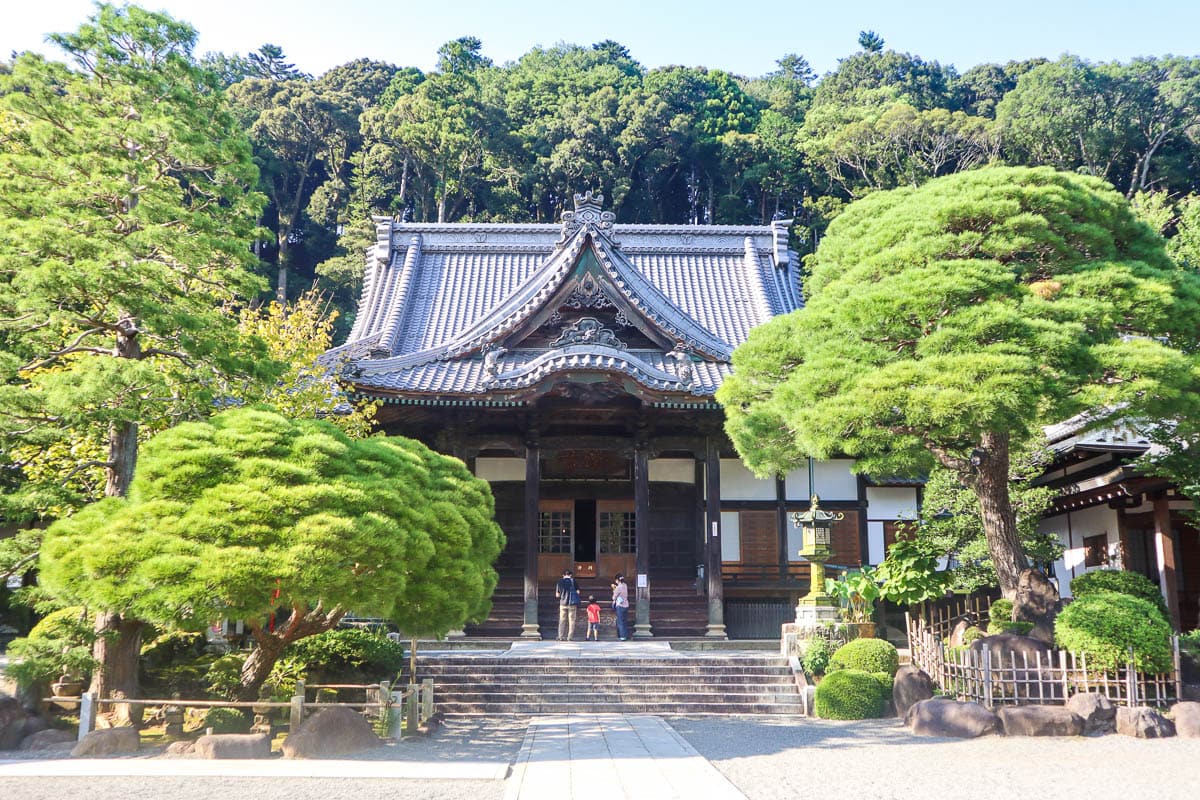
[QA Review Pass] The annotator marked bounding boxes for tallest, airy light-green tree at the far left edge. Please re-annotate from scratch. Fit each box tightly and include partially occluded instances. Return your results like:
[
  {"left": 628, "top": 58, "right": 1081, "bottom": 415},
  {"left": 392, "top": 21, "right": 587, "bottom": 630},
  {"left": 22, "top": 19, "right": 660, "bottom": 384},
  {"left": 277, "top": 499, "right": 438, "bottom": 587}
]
[{"left": 0, "top": 5, "right": 271, "bottom": 696}]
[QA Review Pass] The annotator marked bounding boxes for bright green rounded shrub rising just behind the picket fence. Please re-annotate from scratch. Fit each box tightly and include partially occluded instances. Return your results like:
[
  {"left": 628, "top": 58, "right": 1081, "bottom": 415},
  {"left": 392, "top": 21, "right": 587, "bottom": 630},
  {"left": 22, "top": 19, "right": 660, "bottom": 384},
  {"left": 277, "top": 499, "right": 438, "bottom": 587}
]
[{"left": 1055, "top": 591, "right": 1174, "bottom": 673}]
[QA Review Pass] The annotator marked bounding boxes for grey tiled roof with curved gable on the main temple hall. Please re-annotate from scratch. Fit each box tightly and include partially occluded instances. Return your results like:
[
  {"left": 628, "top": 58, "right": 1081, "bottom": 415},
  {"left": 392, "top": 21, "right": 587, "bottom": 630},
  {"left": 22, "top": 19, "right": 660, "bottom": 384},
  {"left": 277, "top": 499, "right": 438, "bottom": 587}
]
[{"left": 329, "top": 198, "right": 799, "bottom": 396}]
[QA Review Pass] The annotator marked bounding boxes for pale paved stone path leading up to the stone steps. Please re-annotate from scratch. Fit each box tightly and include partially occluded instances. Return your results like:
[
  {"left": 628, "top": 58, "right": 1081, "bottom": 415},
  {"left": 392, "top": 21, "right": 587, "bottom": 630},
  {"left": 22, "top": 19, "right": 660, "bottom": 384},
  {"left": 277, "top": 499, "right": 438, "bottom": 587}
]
[{"left": 504, "top": 714, "right": 745, "bottom": 800}]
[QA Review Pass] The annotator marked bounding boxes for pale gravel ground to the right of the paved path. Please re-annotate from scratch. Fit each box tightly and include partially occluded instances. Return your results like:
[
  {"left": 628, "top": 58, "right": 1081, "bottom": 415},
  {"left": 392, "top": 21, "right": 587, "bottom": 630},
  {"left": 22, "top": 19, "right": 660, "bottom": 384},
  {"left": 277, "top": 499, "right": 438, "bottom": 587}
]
[{"left": 668, "top": 717, "right": 1200, "bottom": 800}]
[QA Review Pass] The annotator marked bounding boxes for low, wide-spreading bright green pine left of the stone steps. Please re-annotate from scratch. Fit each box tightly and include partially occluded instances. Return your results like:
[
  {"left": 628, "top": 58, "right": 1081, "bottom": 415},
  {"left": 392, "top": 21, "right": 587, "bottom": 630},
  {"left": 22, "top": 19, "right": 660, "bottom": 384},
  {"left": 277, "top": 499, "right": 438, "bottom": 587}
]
[{"left": 41, "top": 408, "right": 504, "bottom": 698}]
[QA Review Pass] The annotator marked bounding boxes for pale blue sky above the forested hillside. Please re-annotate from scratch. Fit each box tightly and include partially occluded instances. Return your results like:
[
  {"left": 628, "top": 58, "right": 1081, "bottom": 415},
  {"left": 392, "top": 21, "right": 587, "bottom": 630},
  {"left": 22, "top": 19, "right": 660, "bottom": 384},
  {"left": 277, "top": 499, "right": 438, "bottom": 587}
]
[{"left": 0, "top": 0, "right": 1200, "bottom": 76}]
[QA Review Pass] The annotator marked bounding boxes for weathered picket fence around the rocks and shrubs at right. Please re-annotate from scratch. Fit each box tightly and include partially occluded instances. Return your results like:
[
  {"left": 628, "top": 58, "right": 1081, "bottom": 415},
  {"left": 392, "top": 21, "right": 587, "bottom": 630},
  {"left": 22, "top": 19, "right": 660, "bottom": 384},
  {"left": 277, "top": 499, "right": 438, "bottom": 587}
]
[{"left": 906, "top": 615, "right": 1182, "bottom": 708}]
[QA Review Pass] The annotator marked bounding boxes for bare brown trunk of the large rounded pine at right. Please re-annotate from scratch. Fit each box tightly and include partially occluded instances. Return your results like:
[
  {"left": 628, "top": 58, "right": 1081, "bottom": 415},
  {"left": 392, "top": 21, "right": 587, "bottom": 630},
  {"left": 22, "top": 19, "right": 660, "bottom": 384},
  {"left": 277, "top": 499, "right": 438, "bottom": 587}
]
[{"left": 972, "top": 433, "right": 1030, "bottom": 600}]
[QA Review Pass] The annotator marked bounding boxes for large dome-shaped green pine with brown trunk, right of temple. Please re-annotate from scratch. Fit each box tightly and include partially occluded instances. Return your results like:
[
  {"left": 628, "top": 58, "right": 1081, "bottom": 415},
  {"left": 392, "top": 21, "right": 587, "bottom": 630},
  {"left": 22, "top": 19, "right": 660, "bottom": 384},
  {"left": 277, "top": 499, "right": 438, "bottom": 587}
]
[{"left": 718, "top": 168, "right": 1200, "bottom": 596}]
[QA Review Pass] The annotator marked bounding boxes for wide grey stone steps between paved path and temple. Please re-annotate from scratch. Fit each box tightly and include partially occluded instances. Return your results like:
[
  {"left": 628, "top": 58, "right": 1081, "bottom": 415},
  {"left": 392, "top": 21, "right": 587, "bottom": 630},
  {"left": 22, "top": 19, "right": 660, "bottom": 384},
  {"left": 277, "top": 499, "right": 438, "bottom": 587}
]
[{"left": 408, "top": 642, "right": 800, "bottom": 716}]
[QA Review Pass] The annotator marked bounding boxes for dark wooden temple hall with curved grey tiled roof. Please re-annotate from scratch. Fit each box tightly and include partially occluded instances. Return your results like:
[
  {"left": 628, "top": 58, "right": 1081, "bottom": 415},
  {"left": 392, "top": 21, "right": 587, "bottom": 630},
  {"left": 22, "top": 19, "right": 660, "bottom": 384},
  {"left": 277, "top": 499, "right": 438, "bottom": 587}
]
[{"left": 330, "top": 194, "right": 919, "bottom": 637}]
